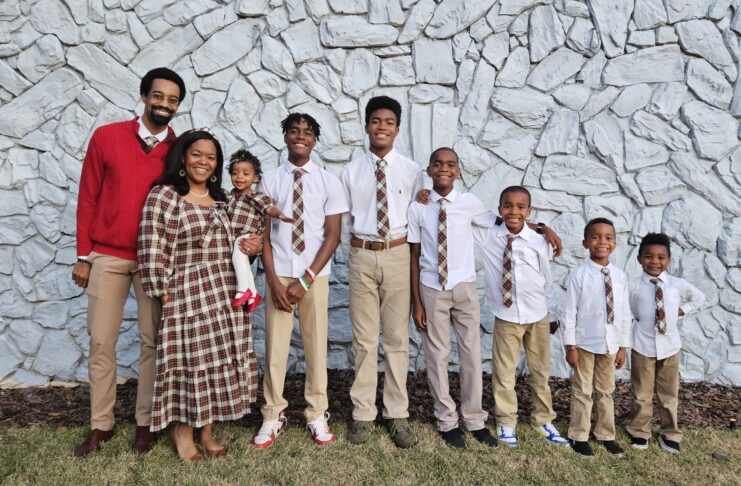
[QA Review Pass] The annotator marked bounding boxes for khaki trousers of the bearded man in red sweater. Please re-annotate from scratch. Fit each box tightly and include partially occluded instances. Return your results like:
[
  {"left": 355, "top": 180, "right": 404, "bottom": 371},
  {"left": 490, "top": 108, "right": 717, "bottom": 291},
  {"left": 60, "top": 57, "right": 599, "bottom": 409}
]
[{"left": 87, "top": 252, "right": 162, "bottom": 430}]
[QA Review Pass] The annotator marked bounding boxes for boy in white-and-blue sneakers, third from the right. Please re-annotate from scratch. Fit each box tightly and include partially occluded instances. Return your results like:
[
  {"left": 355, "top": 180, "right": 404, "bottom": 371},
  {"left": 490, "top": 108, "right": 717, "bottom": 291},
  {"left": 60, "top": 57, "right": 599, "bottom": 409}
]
[{"left": 477, "top": 186, "right": 568, "bottom": 447}]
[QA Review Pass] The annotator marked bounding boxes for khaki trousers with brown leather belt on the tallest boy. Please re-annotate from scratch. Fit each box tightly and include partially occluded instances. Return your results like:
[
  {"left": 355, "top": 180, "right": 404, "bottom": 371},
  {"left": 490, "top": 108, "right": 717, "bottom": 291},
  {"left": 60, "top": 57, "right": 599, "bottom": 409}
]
[{"left": 348, "top": 245, "right": 411, "bottom": 421}]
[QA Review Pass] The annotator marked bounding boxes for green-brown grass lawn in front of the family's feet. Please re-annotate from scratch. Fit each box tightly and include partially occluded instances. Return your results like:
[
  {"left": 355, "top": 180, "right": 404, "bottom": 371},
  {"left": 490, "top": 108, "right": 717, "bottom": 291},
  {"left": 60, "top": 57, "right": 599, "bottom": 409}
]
[{"left": 0, "top": 423, "right": 741, "bottom": 486}]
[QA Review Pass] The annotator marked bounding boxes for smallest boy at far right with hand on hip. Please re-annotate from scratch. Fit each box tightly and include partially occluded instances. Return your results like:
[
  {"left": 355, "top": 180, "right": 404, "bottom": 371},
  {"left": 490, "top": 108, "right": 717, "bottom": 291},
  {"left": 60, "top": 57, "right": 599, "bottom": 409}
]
[{"left": 626, "top": 233, "right": 705, "bottom": 453}]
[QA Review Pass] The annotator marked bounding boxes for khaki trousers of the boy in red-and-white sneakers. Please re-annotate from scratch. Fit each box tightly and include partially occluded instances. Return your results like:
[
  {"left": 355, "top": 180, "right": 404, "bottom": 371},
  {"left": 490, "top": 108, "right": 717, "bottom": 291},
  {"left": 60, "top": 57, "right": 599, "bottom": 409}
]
[{"left": 261, "top": 275, "right": 329, "bottom": 422}]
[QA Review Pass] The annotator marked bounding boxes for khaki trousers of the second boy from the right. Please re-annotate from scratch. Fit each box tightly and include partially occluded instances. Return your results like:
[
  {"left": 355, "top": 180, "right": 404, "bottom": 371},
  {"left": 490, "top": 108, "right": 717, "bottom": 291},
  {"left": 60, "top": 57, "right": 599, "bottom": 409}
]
[{"left": 568, "top": 348, "right": 615, "bottom": 442}]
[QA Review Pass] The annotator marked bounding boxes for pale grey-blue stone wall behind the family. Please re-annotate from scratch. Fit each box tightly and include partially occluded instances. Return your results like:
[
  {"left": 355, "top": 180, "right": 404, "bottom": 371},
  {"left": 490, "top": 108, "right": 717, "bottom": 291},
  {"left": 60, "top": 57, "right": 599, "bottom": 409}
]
[{"left": 0, "top": 0, "right": 741, "bottom": 385}]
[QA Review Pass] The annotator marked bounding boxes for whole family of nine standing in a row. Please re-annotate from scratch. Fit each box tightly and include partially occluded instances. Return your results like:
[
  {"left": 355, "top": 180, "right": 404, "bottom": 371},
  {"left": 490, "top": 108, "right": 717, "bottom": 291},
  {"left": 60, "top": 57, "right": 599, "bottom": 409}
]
[{"left": 73, "top": 68, "right": 703, "bottom": 460}]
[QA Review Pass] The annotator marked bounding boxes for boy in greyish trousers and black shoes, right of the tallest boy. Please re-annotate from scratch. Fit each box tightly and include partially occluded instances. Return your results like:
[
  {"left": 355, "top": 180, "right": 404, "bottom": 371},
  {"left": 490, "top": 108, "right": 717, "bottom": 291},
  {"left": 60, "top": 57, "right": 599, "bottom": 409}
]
[{"left": 407, "top": 147, "right": 497, "bottom": 448}]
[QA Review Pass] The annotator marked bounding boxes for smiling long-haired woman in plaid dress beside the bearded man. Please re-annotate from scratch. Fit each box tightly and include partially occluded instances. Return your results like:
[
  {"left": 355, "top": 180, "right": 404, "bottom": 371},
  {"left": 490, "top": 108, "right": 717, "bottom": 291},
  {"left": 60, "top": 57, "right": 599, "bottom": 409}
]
[{"left": 138, "top": 130, "right": 264, "bottom": 460}]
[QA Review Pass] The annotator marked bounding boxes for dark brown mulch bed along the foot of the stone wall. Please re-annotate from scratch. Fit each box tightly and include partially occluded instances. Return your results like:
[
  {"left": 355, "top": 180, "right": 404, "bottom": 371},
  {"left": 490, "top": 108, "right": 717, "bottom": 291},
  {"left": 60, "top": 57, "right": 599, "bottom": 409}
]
[{"left": 0, "top": 370, "right": 741, "bottom": 428}]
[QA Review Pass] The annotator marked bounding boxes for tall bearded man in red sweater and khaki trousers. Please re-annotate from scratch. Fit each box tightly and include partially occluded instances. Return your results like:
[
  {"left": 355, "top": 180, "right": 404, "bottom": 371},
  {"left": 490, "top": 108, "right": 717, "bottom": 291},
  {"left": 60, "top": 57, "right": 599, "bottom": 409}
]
[{"left": 72, "top": 68, "right": 185, "bottom": 457}]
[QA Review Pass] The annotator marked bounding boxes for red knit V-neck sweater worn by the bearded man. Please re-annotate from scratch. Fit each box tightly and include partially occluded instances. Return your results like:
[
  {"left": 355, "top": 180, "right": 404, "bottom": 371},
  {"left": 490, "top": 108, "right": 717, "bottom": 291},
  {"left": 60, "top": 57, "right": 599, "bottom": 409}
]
[{"left": 77, "top": 118, "right": 175, "bottom": 260}]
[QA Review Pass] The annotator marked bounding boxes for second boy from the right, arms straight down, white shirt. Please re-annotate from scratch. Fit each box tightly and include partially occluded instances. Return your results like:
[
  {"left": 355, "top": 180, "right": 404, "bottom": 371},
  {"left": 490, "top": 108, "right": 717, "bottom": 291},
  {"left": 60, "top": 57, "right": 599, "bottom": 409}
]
[{"left": 562, "top": 218, "right": 631, "bottom": 457}]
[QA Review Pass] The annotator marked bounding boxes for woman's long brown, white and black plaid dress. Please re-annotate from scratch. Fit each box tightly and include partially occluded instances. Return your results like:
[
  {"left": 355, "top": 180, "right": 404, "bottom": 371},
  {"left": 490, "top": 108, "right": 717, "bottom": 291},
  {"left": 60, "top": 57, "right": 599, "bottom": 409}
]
[{"left": 138, "top": 186, "right": 263, "bottom": 431}]
